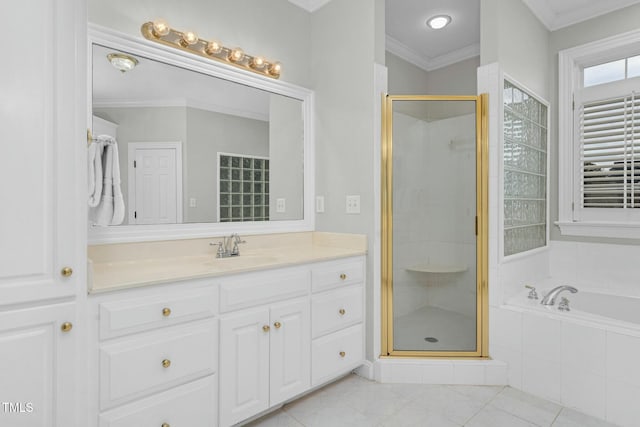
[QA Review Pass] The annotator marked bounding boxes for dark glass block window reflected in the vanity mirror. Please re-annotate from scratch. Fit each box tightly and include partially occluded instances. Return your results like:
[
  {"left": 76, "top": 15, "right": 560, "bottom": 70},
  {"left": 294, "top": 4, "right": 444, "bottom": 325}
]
[{"left": 218, "top": 153, "right": 269, "bottom": 222}]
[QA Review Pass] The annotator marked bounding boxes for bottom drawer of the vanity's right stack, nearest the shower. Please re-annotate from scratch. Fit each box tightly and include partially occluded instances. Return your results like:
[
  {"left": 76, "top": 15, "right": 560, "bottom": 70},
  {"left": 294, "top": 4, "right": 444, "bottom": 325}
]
[{"left": 311, "top": 324, "right": 363, "bottom": 386}]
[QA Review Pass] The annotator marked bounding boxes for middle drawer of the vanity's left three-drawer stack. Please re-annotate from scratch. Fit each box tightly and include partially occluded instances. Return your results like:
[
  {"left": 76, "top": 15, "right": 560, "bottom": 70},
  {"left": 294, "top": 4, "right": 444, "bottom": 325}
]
[{"left": 100, "top": 319, "right": 218, "bottom": 409}]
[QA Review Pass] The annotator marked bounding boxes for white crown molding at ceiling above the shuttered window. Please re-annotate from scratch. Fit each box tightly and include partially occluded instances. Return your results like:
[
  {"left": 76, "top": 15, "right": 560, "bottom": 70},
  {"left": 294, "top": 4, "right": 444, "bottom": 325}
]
[{"left": 523, "top": 0, "right": 640, "bottom": 31}]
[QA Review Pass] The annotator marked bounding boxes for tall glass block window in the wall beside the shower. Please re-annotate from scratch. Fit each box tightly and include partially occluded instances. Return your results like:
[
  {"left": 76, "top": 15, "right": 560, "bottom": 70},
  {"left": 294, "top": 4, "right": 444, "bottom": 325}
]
[{"left": 503, "top": 80, "right": 548, "bottom": 256}]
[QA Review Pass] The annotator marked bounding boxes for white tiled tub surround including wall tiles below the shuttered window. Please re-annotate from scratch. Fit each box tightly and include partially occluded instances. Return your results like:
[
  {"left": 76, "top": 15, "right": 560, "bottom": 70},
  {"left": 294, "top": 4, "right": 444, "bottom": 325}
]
[{"left": 490, "top": 241, "right": 640, "bottom": 426}]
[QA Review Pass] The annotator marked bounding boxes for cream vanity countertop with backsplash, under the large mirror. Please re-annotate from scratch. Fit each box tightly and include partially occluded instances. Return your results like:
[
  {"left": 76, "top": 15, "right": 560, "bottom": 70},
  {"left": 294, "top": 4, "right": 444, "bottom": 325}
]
[{"left": 88, "top": 232, "right": 367, "bottom": 293}]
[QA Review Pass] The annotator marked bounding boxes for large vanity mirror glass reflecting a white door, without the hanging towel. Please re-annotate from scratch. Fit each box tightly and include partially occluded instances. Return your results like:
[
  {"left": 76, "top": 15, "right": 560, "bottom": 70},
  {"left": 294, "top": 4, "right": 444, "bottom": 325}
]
[{"left": 92, "top": 44, "right": 305, "bottom": 229}]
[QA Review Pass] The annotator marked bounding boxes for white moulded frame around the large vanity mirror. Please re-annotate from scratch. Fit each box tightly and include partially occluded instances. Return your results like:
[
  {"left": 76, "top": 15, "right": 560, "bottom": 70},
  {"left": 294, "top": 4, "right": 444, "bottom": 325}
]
[{"left": 87, "top": 23, "right": 315, "bottom": 244}]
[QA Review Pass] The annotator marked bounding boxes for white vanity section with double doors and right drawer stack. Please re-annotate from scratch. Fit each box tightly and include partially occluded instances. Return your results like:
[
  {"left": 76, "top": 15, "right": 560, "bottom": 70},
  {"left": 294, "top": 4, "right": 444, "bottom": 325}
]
[{"left": 219, "top": 257, "right": 364, "bottom": 426}]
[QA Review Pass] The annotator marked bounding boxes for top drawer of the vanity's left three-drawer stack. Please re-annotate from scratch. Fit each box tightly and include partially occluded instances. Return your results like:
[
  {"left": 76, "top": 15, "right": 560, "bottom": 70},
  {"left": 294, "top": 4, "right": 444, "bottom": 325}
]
[{"left": 99, "top": 287, "right": 217, "bottom": 340}]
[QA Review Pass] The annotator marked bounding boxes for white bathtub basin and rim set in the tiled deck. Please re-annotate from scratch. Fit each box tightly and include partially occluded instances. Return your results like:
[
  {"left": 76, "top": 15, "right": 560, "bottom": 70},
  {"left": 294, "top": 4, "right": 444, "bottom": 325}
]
[{"left": 507, "top": 284, "right": 640, "bottom": 332}]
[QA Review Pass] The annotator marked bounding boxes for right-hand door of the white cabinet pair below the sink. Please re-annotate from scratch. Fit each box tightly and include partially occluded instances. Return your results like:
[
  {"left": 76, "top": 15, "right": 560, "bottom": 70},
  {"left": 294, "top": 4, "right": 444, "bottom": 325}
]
[{"left": 269, "top": 298, "right": 311, "bottom": 406}]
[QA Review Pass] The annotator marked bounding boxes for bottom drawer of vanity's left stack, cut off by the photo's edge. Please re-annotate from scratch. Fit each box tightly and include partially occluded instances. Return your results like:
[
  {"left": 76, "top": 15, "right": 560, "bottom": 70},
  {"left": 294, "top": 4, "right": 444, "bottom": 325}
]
[{"left": 99, "top": 375, "right": 218, "bottom": 427}]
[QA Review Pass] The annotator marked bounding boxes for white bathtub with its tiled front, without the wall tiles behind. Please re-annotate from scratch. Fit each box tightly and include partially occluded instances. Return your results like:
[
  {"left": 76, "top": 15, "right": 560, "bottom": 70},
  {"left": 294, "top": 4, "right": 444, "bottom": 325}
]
[{"left": 500, "top": 280, "right": 640, "bottom": 426}]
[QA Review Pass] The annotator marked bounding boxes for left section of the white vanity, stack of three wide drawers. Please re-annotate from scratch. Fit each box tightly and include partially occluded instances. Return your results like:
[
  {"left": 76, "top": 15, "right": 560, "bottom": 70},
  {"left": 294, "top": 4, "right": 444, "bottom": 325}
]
[{"left": 89, "top": 280, "right": 219, "bottom": 427}]
